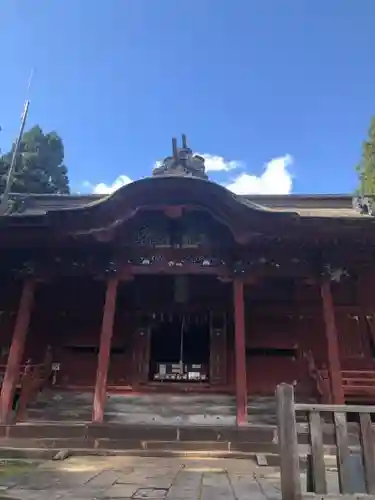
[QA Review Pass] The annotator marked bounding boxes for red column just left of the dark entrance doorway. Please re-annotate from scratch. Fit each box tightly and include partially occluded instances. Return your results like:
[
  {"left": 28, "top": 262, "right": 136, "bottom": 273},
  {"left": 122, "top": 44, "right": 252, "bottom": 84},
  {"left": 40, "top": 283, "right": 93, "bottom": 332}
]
[{"left": 92, "top": 278, "right": 118, "bottom": 423}]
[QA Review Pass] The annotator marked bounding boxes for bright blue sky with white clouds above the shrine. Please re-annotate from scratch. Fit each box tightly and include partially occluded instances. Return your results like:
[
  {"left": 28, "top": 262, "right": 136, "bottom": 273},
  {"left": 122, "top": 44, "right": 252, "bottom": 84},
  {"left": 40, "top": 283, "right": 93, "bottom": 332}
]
[{"left": 0, "top": 0, "right": 375, "bottom": 193}]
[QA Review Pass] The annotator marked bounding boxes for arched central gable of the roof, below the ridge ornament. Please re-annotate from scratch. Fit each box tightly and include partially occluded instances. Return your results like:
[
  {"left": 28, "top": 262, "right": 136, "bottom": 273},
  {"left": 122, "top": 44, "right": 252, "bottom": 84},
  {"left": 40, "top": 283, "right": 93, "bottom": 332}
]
[{"left": 41, "top": 176, "right": 298, "bottom": 236}]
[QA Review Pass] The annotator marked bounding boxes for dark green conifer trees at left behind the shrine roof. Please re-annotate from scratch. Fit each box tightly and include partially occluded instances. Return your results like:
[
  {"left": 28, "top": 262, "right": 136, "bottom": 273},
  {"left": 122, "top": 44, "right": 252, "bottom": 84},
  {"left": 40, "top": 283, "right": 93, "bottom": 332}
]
[{"left": 0, "top": 125, "right": 69, "bottom": 194}]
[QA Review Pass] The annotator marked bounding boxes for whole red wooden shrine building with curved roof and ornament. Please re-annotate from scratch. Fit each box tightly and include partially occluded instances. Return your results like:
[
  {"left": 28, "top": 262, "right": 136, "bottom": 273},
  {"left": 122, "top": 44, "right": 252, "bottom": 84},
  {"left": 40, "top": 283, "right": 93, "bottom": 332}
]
[{"left": 0, "top": 136, "right": 375, "bottom": 425}]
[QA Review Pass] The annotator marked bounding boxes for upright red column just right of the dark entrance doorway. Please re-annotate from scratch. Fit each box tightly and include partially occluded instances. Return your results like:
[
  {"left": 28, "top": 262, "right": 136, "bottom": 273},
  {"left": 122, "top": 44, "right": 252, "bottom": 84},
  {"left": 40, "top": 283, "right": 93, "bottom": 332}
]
[{"left": 233, "top": 279, "right": 247, "bottom": 425}]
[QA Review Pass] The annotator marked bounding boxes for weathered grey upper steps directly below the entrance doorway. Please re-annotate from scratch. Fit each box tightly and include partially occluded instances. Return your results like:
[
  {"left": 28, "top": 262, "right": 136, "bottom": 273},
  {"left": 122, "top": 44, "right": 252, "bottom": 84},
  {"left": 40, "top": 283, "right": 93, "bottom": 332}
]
[{"left": 28, "top": 390, "right": 276, "bottom": 426}]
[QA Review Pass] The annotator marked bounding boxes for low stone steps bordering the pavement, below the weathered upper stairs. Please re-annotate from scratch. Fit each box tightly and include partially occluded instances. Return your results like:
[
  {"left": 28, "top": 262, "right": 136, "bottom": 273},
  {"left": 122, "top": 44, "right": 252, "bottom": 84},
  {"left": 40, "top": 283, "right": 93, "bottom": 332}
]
[{"left": 0, "top": 422, "right": 277, "bottom": 458}]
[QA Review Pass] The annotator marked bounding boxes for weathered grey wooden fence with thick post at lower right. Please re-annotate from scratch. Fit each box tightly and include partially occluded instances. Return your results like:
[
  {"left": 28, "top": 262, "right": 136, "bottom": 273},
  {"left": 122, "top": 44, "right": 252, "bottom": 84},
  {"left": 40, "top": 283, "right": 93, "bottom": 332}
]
[{"left": 276, "top": 384, "right": 375, "bottom": 500}]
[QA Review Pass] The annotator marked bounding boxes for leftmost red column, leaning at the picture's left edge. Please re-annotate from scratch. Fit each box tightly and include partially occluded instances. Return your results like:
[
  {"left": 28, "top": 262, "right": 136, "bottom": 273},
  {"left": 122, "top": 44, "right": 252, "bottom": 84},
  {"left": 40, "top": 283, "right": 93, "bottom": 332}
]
[{"left": 0, "top": 280, "right": 35, "bottom": 423}]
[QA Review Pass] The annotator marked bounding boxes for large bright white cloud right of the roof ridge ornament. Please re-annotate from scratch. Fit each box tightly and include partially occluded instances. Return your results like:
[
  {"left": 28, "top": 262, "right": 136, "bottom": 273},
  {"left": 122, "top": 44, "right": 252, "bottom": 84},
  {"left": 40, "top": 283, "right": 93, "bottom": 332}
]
[{"left": 226, "top": 155, "right": 293, "bottom": 194}]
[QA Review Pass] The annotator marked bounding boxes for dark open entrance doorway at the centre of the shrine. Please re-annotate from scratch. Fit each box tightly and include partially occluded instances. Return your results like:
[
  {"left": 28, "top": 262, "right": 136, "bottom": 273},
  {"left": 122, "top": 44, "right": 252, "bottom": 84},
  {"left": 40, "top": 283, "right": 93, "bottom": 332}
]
[{"left": 149, "top": 314, "right": 210, "bottom": 383}]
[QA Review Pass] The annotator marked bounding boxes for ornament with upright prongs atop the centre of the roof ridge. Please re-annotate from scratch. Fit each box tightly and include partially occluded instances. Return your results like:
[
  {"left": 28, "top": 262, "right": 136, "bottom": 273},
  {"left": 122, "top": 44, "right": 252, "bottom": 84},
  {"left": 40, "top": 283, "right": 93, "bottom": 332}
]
[{"left": 152, "top": 134, "right": 208, "bottom": 179}]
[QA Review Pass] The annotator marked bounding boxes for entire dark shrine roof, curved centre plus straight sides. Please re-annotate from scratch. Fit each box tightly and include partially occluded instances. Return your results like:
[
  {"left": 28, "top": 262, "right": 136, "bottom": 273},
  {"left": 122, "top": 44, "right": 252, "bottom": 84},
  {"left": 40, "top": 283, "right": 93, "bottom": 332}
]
[{"left": 0, "top": 175, "right": 375, "bottom": 242}]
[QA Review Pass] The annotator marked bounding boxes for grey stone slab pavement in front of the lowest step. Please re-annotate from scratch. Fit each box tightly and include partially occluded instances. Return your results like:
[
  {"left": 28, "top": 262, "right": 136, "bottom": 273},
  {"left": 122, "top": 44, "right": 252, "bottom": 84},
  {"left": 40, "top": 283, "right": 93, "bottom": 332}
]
[{"left": 0, "top": 457, "right": 280, "bottom": 500}]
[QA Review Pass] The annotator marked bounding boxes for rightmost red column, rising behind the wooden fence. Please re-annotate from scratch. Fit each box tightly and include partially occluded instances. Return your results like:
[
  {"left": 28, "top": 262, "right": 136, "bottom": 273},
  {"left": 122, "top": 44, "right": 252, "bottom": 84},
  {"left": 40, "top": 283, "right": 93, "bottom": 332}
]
[{"left": 320, "top": 280, "right": 345, "bottom": 404}]
